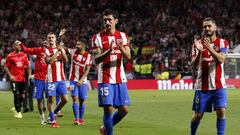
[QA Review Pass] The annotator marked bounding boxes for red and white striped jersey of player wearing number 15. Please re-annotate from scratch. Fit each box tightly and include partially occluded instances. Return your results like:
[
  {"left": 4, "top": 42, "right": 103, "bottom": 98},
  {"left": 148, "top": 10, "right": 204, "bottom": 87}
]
[{"left": 92, "top": 31, "right": 129, "bottom": 84}]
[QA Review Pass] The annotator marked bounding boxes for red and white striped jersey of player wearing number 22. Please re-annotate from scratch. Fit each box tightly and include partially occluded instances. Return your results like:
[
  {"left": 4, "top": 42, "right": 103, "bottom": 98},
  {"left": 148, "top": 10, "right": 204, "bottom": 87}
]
[{"left": 45, "top": 48, "right": 65, "bottom": 82}]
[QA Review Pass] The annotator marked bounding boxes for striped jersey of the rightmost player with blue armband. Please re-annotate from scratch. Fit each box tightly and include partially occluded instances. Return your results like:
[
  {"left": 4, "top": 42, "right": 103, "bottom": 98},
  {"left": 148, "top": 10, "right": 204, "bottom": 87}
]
[{"left": 192, "top": 38, "right": 229, "bottom": 90}]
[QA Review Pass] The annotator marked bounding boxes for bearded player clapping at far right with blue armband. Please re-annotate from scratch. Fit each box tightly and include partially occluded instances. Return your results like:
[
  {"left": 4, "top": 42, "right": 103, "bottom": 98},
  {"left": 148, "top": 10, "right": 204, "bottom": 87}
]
[{"left": 191, "top": 17, "right": 229, "bottom": 135}]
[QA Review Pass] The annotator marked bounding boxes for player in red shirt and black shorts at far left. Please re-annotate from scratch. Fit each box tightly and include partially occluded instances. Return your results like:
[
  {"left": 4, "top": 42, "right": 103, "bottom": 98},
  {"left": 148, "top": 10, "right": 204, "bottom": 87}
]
[{"left": 4, "top": 40, "right": 31, "bottom": 118}]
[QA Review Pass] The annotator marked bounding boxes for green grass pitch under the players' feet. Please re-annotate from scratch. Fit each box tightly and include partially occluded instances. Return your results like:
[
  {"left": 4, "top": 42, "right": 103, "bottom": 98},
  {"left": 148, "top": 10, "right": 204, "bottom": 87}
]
[{"left": 0, "top": 90, "right": 240, "bottom": 135}]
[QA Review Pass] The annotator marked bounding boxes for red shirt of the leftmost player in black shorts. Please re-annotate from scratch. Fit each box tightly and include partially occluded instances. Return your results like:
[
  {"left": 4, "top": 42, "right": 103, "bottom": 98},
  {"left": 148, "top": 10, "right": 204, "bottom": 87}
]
[{"left": 5, "top": 52, "right": 30, "bottom": 82}]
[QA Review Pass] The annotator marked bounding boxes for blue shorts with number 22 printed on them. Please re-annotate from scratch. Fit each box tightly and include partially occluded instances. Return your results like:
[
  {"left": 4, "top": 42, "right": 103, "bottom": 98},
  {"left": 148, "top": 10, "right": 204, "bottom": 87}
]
[{"left": 47, "top": 81, "right": 68, "bottom": 97}]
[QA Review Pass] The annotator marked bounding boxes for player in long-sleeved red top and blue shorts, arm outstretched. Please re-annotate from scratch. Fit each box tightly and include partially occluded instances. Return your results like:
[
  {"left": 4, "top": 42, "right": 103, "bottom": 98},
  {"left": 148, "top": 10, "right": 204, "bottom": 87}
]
[{"left": 19, "top": 41, "right": 49, "bottom": 125}]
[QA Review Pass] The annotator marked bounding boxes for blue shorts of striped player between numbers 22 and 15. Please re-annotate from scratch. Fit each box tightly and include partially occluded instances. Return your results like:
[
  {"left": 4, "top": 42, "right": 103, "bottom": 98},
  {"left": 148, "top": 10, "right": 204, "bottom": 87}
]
[{"left": 70, "top": 81, "right": 88, "bottom": 99}]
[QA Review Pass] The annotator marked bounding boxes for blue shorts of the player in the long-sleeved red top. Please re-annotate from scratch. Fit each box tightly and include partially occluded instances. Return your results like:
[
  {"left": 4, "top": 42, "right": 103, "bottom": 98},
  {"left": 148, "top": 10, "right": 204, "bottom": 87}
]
[{"left": 33, "top": 80, "right": 47, "bottom": 99}]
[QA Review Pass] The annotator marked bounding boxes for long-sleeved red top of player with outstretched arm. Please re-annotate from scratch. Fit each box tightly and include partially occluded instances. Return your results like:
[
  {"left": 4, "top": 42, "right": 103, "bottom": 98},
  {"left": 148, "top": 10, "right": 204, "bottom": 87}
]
[{"left": 21, "top": 44, "right": 47, "bottom": 80}]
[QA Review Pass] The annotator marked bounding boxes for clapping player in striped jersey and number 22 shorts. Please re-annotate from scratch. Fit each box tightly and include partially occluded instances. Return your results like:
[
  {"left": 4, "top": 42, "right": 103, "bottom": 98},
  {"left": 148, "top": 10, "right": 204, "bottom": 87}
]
[{"left": 45, "top": 32, "right": 68, "bottom": 128}]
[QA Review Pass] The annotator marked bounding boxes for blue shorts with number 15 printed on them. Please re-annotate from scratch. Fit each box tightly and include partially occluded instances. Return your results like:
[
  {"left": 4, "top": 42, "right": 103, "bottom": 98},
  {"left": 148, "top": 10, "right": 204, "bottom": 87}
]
[{"left": 98, "top": 83, "right": 130, "bottom": 107}]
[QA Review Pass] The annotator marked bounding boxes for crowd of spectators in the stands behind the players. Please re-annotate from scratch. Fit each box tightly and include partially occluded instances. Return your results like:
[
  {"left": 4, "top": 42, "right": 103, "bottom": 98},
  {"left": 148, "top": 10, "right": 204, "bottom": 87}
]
[{"left": 0, "top": 0, "right": 240, "bottom": 79}]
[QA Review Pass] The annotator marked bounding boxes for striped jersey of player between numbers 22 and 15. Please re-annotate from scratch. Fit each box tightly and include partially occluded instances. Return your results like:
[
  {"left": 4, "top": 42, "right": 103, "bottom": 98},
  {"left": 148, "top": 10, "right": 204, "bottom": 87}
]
[{"left": 66, "top": 49, "right": 92, "bottom": 83}]
